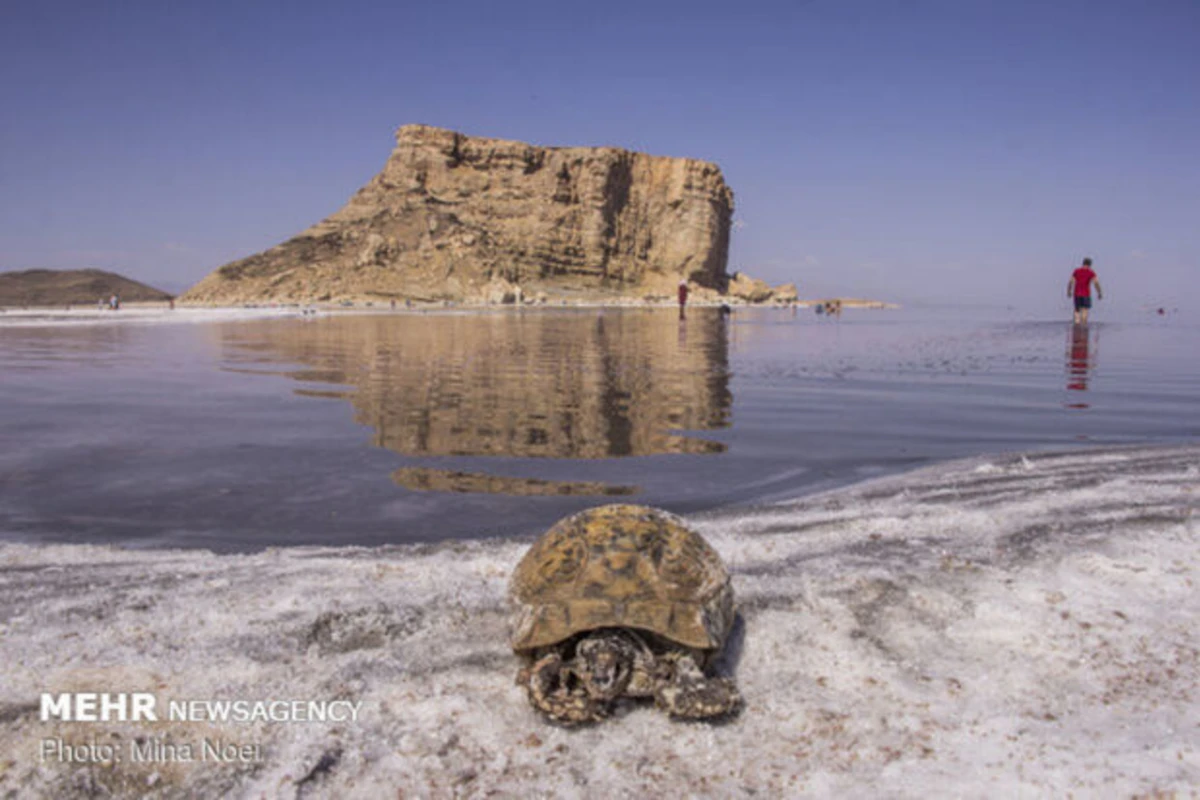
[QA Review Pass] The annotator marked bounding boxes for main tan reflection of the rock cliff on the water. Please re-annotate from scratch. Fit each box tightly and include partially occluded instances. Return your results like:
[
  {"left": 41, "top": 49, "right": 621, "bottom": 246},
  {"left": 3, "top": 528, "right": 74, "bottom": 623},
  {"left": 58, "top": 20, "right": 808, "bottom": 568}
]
[{"left": 226, "top": 309, "right": 732, "bottom": 465}]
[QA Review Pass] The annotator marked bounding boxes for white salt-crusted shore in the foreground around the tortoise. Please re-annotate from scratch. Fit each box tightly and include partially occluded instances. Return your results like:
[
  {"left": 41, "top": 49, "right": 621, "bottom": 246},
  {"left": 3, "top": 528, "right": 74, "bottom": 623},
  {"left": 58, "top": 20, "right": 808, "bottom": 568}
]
[{"left": 0, "top": 446, "right": 1200, "bottom": 798}]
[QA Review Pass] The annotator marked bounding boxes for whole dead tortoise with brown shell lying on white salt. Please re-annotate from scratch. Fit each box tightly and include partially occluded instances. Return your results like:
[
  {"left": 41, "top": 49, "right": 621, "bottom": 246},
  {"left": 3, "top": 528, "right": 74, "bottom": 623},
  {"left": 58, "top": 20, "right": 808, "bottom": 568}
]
[{"left": 509, "top": 505, "right": 742, "bottom": 724}]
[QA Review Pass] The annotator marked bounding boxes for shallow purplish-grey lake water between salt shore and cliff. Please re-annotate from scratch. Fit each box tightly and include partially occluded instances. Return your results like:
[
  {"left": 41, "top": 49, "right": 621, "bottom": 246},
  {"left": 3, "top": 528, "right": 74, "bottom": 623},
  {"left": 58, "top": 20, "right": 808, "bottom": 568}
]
[{"left": 0, "top": 303, "right": 1200, "bottom": 551}]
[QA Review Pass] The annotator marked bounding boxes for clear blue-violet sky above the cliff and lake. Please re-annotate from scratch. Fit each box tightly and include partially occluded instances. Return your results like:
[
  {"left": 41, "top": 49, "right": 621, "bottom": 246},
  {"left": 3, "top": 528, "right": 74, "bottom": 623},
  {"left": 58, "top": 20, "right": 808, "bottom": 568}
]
[{"left": 0, "top": 0, "right": 1200, "bottom": 308}]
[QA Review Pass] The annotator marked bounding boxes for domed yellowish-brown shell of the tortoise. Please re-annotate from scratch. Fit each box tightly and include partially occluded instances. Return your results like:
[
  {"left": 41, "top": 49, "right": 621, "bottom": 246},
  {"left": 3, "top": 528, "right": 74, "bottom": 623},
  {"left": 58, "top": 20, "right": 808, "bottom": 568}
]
[{"left": 509, "top": 505, "right": 733, "bottom": 652}]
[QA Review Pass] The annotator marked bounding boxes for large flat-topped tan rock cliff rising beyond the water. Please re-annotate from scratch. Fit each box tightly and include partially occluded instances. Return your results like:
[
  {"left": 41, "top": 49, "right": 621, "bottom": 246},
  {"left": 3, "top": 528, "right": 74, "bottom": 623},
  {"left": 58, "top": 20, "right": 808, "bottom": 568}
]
[{"left": 182, "top": 125, "right": 733, "bottom": 303}]
